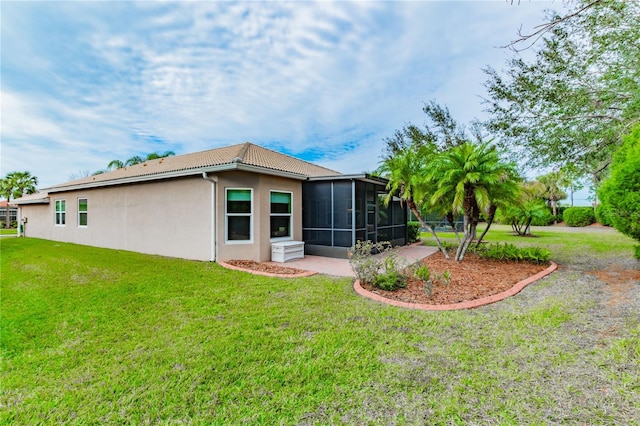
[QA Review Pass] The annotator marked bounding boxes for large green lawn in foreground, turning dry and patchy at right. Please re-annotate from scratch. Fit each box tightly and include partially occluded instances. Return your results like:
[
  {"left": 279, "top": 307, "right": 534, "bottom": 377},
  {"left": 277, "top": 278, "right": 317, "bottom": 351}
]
[{"left": 0, "top": 233, "right": 640, "bottom": 425}]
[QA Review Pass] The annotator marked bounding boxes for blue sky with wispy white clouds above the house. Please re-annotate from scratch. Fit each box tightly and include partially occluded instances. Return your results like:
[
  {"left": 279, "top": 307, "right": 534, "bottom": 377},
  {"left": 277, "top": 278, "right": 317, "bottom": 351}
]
[{"left": 0, "top": 0, "right": 562, "bottom": 187}]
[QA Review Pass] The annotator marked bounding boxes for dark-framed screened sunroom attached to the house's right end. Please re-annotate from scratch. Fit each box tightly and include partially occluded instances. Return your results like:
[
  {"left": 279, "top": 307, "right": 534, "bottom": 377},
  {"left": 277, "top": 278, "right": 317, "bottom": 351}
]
[{"left": 302, "top": 174, "right": 407, "bottom": 258}]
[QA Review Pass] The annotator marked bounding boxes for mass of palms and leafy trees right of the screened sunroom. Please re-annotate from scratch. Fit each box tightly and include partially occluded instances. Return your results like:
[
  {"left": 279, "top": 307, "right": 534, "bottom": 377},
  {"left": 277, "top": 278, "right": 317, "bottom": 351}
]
[{"left": 378, "top": 0, "right": 640, "bottom": 260}]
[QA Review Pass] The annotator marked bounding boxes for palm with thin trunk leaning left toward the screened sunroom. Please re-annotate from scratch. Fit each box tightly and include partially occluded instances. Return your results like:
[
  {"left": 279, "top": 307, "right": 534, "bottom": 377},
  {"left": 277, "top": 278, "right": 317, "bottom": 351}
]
[{"left": 377, "top": 143, "right": 449, "bottom": 259}]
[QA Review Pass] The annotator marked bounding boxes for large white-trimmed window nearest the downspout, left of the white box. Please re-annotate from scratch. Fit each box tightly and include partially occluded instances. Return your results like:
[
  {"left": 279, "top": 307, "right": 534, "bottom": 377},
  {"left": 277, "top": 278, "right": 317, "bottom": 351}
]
[{"left": 225, "top": 188, "right": 253, "bottom": 242}]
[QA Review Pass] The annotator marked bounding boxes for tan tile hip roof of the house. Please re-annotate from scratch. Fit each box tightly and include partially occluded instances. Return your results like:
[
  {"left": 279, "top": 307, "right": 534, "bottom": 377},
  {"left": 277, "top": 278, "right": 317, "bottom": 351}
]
[{"left": 45, "top": 142, "right": 340, "bottom": 192}]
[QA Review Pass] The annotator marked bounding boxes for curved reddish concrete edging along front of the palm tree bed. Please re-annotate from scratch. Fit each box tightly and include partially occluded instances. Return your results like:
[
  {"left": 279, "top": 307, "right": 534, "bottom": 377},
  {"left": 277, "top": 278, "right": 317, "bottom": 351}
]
[{"left": 353, "top": 262, "right": 558, "bottom": 311}]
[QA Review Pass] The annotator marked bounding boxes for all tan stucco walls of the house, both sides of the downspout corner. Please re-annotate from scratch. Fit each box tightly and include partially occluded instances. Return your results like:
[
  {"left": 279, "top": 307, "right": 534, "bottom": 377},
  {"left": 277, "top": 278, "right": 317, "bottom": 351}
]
[{"left": 21, "top": 172, "right": 302, "bottom": 261}]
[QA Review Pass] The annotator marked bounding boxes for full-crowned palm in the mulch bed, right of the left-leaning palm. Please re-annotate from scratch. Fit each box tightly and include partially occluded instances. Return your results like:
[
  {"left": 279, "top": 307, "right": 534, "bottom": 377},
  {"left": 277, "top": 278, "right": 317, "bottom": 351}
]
[{"left": 428, "top": 142, "right": 515, "bottom": 261}]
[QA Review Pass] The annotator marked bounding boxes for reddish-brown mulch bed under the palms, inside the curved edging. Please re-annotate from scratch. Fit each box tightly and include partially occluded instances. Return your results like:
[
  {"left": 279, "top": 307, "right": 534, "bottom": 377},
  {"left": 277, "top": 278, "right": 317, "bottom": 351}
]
[{"left": 361, "top": 253, "right": 549, "bottom": 305}]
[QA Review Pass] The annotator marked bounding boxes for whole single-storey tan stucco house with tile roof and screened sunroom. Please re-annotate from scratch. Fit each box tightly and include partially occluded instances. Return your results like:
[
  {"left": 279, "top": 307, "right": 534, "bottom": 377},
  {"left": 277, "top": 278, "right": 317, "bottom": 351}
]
[{"left": 14, "top": 142, "right": 407, "bottom": 261}]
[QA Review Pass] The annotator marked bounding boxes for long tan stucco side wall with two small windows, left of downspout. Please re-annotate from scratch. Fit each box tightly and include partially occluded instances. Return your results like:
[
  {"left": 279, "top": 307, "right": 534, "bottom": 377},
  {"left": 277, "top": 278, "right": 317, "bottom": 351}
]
[{"left": 22, "top": 177, "right": 212, "bottom": 260}]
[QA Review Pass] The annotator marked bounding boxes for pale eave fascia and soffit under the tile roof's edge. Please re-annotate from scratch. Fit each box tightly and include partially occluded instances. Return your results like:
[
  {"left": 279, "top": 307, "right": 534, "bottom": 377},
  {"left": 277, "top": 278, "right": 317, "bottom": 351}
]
[{"left": 44, "top": 163, "right": 307, "bottom": 193}]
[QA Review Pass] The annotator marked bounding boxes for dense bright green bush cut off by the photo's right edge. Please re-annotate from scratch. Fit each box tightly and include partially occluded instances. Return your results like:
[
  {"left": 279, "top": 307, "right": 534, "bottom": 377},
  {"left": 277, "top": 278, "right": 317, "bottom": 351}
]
[{"left": 598, "top": 124, "right": 640, "bottom": 248}]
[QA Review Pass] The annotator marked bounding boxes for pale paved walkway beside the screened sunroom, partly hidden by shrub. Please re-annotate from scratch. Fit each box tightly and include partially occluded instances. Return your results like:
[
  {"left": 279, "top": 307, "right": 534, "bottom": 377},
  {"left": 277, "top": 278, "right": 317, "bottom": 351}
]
[{"left": 277, "top": 244, "right": 438, "bottom": 278}]
